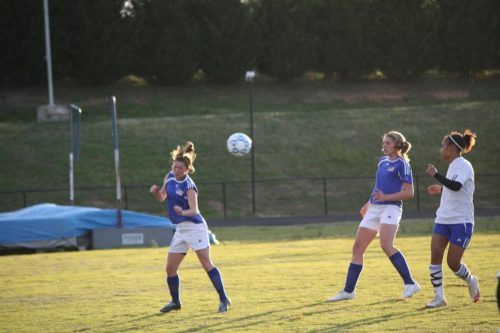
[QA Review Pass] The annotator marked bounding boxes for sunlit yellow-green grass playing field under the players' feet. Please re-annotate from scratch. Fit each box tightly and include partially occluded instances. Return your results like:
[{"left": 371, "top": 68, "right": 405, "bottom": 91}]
[{"left": 0, "top": 218, "right": 500, "bottom": 332}]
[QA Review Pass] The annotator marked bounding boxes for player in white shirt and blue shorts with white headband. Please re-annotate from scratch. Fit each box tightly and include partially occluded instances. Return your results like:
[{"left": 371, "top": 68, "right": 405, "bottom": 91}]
[{"left": 426, "top": 130, "right": 480, "bottom": 308}]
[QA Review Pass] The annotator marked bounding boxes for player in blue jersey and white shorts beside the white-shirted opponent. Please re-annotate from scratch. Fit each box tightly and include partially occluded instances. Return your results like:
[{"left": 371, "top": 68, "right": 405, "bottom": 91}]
[{"left": 329, "top": 131, "right": 420, "bottom": 302}]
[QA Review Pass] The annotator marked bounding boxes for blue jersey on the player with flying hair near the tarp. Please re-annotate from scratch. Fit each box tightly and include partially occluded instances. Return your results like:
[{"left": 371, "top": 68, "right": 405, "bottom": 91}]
[{"left": 165, "top": 171, "right": 205, "bottom": 224}]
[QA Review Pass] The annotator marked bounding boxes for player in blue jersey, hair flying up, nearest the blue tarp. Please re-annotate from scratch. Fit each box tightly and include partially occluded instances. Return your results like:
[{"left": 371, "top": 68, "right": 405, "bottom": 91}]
[{"left": 150, "top": 141, "right": 231, "bottom": 313}]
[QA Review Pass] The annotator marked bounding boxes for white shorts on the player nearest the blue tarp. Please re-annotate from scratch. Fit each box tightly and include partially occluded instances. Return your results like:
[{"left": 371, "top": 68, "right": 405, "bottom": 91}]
[{"left": 168, "top": 222, "right": 210, "bottom": 253}]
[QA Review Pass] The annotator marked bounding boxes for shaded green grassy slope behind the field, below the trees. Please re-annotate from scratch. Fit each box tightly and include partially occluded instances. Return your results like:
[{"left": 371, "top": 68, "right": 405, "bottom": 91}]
[{"left": 0, "top": 80, "right": 500, "bottom": 218}]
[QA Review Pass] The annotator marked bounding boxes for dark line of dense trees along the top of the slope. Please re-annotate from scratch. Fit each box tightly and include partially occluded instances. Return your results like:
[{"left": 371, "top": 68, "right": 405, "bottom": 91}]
[{"left": 0, "top": 0, "right": 500, "bottom": 86}]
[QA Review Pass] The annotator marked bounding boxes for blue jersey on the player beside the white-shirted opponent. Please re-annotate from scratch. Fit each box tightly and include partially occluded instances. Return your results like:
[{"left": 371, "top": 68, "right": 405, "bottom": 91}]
[{"left": 370, "top": 156, "right": 413, "bottom": 207}]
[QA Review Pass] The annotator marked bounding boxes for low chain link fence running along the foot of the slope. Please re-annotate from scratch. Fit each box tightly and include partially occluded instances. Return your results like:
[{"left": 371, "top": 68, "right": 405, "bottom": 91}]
[{"left": 0, "top": 174, "right": 500, "bottom": 219}]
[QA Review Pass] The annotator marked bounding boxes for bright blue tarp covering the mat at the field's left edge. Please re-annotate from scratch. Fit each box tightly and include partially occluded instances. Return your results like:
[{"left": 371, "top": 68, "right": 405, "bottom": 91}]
[{"left": 0, "top": 204, "right": 175, "bottom": 245}]
